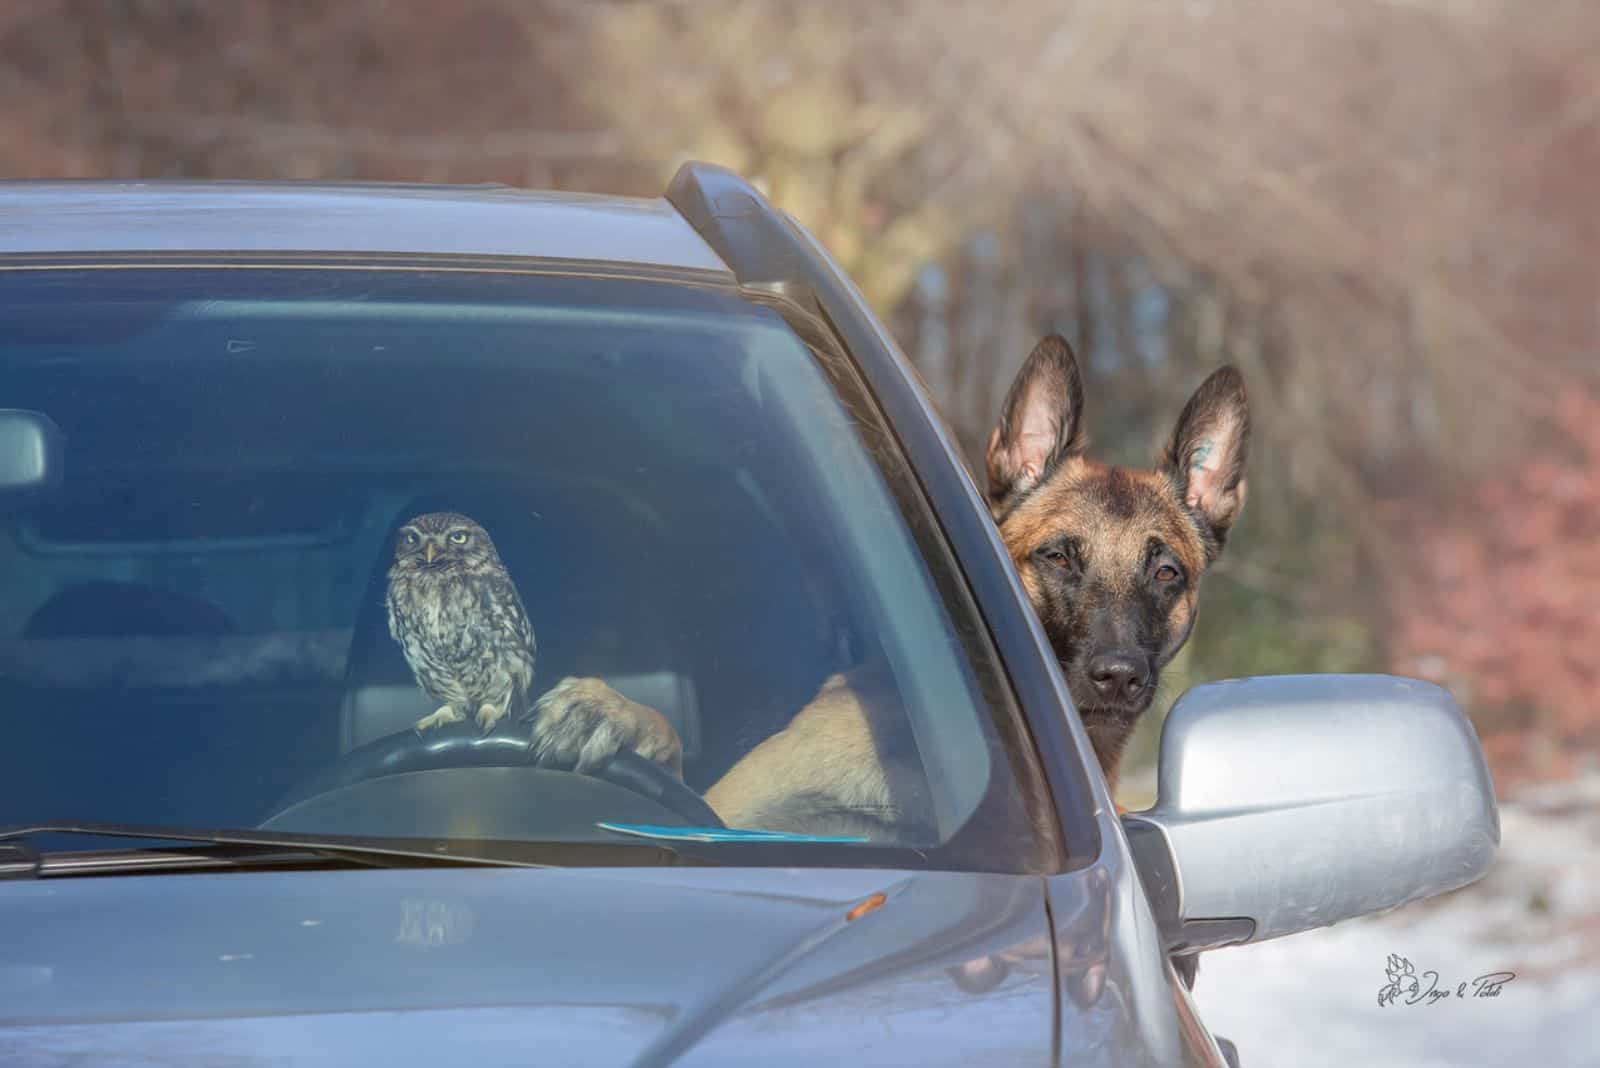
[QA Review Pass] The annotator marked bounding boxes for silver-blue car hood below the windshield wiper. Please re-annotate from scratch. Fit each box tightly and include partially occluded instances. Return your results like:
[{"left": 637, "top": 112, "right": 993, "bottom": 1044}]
[{"left": 0, "top": 868, "right": 1054, "bottom": 1065}]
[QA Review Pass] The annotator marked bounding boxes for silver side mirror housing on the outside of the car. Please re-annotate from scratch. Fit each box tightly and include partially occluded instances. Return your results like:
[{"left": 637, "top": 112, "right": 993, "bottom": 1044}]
[{"left": 1123, "top": 675, "right": 1499, "bottom": 953}]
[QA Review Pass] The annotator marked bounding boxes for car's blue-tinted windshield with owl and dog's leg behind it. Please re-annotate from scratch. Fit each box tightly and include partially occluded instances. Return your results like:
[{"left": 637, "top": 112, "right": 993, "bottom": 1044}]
[{"left": 0, "top": 265, "right": 1053, "bottom": 870}]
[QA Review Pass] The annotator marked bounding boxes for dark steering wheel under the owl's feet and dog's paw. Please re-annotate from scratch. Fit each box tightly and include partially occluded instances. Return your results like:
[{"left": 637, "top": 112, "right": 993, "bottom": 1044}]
[{"left": 264, "top": 721, "right": 723, "bottom": 828}]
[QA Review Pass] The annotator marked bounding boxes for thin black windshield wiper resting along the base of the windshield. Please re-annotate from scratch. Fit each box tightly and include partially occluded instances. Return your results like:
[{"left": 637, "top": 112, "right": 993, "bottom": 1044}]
[{"left": 0, "top": 820, "right": 704, "bottom": 879}]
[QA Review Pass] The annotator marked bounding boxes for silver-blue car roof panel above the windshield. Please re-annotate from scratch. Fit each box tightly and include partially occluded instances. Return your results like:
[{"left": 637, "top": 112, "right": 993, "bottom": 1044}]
[{"left": 0, "top": 181, "right": 733, "bottom": 274}]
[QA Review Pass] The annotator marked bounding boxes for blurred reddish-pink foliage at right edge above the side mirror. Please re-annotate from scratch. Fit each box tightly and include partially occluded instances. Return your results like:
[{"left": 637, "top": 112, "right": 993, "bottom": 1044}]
[{"left": 1389, "top": 389, "right": 1600, "bottom": 787}]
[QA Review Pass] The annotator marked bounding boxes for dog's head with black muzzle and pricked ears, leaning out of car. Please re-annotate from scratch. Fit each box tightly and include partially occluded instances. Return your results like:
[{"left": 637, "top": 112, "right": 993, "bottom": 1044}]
[{"left": 987, "top": 336, "right": 1250, "bottom": 791}]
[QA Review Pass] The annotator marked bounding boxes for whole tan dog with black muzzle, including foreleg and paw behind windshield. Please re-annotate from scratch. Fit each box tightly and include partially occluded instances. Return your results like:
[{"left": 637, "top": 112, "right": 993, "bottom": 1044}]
[{"left": 539, "top": 334, "right": 1250, "bottom": 839}]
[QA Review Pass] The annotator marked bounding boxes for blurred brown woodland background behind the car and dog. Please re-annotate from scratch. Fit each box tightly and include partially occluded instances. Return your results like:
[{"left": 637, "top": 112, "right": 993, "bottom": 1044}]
[{"left": 0, "top": 0, "right": 1600, "bottom": 791}]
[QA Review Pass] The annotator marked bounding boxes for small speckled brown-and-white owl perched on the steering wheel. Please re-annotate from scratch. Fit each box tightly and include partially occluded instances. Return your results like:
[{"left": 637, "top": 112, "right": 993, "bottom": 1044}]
[{"left": 387, "top": 512, "right": 538, "bottom": 734}]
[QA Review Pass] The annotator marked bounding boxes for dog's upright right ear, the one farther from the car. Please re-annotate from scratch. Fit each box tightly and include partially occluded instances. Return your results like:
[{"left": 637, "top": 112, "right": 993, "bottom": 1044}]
[{"left": 1162, "top": 368, "right": 1250, "bottom": 558}]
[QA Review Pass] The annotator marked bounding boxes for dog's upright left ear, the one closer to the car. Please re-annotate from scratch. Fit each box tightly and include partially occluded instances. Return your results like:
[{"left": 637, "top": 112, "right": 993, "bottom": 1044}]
[{"left": 987, "top": 334, "right": 1083, "bottom": 510}]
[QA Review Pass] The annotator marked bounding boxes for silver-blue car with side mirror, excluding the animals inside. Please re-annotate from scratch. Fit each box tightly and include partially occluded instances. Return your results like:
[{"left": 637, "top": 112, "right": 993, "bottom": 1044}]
[{"left": 0, "top": 165, "right": 1499, "bottom": 1068}]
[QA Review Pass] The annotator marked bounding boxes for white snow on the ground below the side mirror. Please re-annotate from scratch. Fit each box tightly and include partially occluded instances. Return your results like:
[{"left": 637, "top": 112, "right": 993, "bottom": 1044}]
[{"left": 1195, "top": 774, "right": 1600, "bottom": 1068}]
